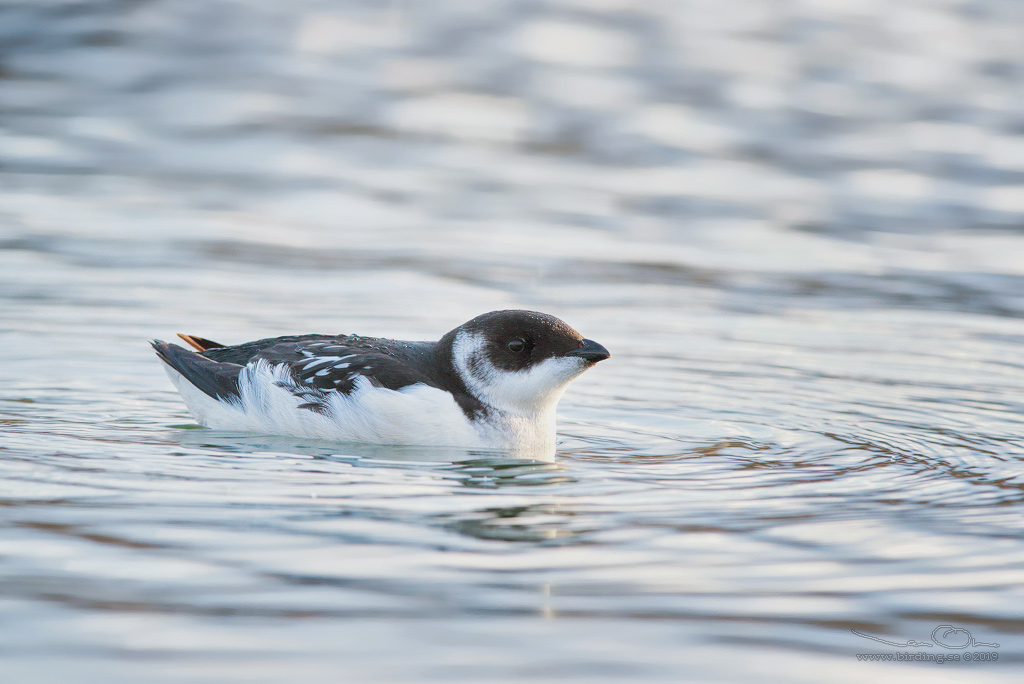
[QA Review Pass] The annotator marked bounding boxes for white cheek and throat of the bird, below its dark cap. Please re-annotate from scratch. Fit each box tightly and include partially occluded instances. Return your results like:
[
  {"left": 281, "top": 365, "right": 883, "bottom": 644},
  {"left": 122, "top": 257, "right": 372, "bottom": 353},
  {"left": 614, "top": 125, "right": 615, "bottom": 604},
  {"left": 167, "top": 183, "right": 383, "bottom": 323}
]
[{"left": 453, "top": 333, "right": 588, "bottom": 415}]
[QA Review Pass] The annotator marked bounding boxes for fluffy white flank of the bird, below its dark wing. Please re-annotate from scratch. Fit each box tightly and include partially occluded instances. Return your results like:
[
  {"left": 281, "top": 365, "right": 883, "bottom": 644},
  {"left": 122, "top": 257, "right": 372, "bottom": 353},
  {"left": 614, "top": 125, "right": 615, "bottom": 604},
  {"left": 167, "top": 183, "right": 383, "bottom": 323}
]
[{"left": 158, "top": 360, "right": 479, "bottom": 447}]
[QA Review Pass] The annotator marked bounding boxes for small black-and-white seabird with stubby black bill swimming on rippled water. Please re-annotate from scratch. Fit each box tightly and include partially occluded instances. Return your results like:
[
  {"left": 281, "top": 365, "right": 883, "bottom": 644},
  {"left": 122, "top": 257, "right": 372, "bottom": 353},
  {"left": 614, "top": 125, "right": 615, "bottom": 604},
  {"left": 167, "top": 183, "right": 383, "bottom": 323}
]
[{"left": 152, "top": 309, "right": 610, "bottom": 452}]
